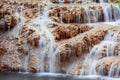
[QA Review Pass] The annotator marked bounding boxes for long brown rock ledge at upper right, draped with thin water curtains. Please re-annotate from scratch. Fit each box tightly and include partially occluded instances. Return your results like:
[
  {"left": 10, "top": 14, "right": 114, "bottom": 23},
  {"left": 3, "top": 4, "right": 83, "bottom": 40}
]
[{"left": 49, "top": 3, "right": 120, "bottom": 23}]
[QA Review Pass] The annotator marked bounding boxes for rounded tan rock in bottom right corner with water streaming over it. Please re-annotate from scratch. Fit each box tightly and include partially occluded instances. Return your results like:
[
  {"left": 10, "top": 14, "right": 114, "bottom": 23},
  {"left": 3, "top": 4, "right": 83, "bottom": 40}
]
[{"left": 95, "top": 57, "right": 120, "bottom": 78}]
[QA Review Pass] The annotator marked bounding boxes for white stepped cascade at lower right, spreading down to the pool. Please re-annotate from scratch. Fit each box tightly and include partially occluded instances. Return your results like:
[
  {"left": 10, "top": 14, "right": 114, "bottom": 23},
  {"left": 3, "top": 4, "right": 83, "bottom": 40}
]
[{"left": 80, "top": 31, "right": 120, "bottom": 77}]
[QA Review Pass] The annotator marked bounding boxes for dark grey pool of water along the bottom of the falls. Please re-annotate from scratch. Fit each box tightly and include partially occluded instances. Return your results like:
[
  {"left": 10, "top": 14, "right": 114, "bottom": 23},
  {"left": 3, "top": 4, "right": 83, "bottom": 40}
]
[{"left": 0, "top": 72, "right": 120, "bottom": 80}]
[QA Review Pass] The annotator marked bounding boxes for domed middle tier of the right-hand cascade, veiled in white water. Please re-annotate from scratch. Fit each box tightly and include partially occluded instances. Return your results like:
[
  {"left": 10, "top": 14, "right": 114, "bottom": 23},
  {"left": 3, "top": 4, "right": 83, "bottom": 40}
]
[{"left": 89, "top": 41, "right": 117, "bottom": 60}]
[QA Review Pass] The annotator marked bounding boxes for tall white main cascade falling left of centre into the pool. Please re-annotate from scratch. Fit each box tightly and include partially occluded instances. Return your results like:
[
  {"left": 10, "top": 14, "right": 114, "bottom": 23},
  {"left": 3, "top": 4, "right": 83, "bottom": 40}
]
[{"left": 27, "top": 7, "right": 58, "bottom": 72}]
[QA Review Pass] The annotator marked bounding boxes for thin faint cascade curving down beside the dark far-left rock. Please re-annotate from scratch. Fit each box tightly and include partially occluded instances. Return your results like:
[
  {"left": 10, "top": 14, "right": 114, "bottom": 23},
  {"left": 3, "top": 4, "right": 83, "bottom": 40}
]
[{"left": 3, "top": 3, "right": 27, "bottom": 72}]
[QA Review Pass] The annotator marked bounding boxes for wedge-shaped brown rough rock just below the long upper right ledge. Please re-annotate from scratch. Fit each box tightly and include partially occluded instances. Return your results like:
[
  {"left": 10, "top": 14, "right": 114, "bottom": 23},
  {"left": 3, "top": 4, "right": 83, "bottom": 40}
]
[{"left": 53, "top": 24, "right": 92, "bottom": 40}]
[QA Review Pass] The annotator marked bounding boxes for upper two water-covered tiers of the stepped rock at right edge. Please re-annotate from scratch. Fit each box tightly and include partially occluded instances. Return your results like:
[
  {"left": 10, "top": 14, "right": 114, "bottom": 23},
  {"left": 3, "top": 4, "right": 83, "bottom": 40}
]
[{"left": 90, "top": 28, "right": 120, "bottom": 59}]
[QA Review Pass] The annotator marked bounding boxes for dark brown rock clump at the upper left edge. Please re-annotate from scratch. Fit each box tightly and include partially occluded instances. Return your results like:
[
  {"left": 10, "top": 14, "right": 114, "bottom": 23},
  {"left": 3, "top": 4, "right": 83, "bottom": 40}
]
[{"left": 0, "top": 2, "right": 17, "bottom": 30}]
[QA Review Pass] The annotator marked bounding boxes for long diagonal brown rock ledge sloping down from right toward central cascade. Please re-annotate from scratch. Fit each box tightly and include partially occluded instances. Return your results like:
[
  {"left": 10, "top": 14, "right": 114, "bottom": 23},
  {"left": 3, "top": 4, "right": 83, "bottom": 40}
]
[{"left": 54, "top": 25, "right": 113, "bottom": 72}]
